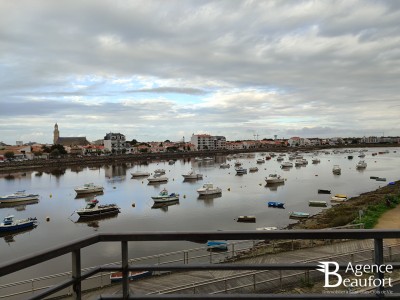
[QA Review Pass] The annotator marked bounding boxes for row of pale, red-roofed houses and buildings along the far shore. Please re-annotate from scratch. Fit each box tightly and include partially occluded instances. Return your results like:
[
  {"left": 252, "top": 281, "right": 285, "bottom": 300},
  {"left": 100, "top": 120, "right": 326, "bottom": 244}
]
[{"left": 0, "top": 133, "right": 400, "bottom": 161}]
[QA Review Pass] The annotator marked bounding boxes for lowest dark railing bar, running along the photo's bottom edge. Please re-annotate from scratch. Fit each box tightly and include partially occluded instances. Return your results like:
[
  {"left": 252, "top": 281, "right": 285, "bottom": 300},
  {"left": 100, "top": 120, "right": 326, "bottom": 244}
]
[{"left": 98, "top": 293, "right": 400, "bottom": 300}]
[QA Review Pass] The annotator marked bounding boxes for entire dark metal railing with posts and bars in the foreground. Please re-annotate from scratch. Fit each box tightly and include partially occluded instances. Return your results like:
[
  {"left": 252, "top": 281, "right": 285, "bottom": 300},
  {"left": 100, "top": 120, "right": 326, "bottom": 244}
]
[{"left": 0, "top": 229, "right": 400, "bottom": 299}]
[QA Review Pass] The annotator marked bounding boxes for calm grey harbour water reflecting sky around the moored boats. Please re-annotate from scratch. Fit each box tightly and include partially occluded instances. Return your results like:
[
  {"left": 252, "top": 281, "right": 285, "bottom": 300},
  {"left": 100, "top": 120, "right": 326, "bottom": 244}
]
[{"left": 0, "top": 148, "right": 400, "bottom": 283}]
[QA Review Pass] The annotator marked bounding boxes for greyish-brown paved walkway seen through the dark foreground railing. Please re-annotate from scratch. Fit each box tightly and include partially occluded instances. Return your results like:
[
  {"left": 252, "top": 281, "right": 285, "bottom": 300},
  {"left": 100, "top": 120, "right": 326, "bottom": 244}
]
[{"left": 75, "top": 240, "right": 400, "bottom": 300}]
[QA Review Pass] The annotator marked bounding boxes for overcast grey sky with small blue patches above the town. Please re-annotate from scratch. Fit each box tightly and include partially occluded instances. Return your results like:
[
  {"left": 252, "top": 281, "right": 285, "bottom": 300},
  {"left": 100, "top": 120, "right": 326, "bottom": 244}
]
[{"left": 0, "top": 0, "right": 400, "bottom": 144}]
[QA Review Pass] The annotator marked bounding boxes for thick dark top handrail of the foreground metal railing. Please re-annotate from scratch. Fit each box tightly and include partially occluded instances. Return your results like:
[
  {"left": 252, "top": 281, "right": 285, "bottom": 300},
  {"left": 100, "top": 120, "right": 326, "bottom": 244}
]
[{"left": 0, "top": 229, "right": 400, "bottom": 277}]
